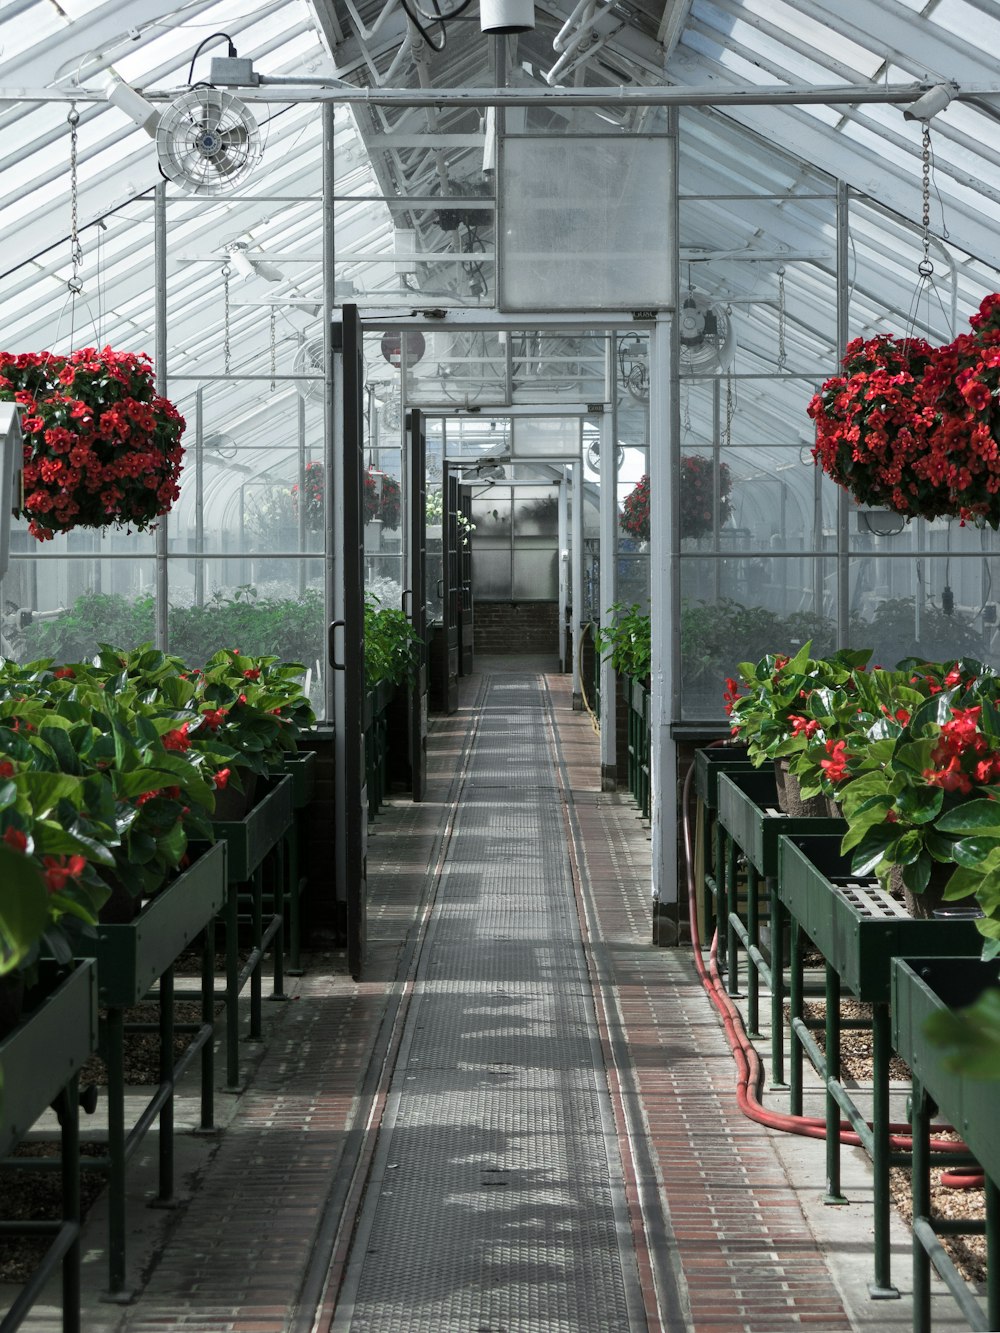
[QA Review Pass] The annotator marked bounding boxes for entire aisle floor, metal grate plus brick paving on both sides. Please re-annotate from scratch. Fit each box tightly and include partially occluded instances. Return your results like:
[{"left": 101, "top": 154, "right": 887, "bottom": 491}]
[{"left": 11, "top": 659, "right": 976, "bottom": 1333}]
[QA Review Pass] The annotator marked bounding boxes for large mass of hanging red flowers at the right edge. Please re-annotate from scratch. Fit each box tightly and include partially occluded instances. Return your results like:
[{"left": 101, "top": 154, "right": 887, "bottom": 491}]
[{"left": 808, "top": 293, "right": 1000, "bottom": 528}]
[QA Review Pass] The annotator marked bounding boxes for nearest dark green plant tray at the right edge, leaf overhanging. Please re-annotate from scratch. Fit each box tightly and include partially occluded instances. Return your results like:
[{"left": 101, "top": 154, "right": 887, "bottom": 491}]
[{"left": 892, "top": 954, "right": 1000, "bottom": 1184}]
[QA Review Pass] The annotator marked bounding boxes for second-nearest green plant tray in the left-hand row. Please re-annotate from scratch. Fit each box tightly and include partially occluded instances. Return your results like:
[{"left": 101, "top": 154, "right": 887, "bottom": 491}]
[{"left": 83, "top": 842, "right": 225, "bottom": 1009}]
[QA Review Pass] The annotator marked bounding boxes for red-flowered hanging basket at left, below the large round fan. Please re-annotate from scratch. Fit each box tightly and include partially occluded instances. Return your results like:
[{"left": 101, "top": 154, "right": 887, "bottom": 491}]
[{"left": 0, "top": 347, "right": 184, "bottom": 541}]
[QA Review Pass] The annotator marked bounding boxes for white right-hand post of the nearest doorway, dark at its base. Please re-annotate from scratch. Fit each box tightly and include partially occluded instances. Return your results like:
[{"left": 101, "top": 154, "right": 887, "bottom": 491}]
[{"left": 649, "top": 312, "right": 677, "bottom": 944}]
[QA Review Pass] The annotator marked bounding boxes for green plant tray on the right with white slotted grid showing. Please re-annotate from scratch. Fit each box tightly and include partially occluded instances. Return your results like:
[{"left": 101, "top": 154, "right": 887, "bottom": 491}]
[{"left": 777, "top": 821, "right": 983, "bottom": 1002}]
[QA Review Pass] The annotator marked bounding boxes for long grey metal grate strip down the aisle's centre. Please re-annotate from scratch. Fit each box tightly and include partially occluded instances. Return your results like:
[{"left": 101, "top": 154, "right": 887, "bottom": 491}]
[{"left": 332, "top": 674, "right": 647, "bottom": 1333}]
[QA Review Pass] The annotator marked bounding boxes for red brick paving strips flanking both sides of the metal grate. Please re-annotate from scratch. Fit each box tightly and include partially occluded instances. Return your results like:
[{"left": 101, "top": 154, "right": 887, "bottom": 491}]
[{"left": 9, "top": 661, "right": 965, "bottom": 1333}]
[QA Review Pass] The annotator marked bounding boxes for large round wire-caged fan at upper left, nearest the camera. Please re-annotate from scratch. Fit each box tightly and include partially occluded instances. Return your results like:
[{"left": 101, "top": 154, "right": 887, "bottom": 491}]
[{"left": 156, "top": 88, "right": 264, "bottom": 195}]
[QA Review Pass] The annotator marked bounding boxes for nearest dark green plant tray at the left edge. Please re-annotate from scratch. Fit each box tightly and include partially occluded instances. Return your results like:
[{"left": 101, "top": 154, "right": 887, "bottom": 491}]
[{"left": 0, "top": 958, "right": 97, "bottom": 1157}]
